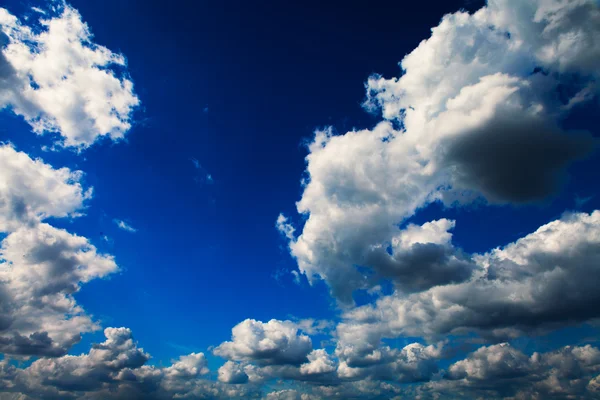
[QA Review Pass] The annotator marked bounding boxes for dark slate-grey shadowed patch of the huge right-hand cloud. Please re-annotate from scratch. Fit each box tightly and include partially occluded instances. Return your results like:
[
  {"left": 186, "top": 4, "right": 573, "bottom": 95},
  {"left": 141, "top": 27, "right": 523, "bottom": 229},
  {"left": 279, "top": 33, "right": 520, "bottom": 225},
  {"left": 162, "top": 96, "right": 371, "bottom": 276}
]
[{"left": 444, "top": 114, "right": 597, "bottom": 203}]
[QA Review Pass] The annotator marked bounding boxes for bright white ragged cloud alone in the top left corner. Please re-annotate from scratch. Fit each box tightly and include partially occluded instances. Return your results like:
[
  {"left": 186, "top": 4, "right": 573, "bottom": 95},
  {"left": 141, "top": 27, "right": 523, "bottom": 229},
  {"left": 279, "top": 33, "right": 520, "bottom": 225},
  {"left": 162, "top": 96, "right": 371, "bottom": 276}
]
[{"left": 0, "top": 6, "right": 139, "bottom": 148}]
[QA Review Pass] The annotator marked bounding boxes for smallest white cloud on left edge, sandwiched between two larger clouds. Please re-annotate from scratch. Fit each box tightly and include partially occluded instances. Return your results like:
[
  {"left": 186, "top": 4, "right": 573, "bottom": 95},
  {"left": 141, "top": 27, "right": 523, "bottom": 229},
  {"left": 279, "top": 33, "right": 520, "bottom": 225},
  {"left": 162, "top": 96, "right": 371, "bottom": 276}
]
[{"left": 0, "top": 145, "right": 92, "bottom": 232}]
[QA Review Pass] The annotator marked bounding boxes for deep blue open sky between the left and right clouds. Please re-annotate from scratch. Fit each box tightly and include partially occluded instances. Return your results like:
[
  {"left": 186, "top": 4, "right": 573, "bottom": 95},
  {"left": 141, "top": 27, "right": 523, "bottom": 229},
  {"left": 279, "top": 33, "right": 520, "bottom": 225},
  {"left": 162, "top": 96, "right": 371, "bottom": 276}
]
[{"left": 0, "top": 0, "right": 600, "bottom": 372}]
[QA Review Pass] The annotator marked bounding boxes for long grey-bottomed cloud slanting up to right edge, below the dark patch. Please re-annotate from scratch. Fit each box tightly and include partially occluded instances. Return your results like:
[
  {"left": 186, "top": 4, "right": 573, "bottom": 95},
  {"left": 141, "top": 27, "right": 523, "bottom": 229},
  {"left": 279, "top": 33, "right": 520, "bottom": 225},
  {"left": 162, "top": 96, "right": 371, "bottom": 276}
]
[{"left": 338, "top": 211, "right": 600, "bottom": 345}]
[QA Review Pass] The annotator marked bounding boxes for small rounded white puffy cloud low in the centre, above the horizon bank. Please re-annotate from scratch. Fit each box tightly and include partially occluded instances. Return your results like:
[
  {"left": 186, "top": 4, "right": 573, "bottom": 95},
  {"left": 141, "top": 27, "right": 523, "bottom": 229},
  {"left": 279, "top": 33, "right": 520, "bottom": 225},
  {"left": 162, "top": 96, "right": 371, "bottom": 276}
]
[{"left": 214, "top": 319, "right": 312, "bottom": 365}]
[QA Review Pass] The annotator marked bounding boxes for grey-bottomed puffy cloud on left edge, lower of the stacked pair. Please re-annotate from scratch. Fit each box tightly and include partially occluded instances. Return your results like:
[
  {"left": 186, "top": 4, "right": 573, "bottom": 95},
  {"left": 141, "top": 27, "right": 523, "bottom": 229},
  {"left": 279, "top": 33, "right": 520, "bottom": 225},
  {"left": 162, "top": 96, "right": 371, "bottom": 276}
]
[{"left": 0, "top": 223, "right": 117, "bottom": 356}]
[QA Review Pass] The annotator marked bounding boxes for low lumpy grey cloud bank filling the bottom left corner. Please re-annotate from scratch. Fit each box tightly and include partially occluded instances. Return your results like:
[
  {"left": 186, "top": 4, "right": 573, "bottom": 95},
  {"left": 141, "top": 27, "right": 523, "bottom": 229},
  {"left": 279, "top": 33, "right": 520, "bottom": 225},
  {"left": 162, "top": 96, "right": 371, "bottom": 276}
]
[{"left": 0, "top": 328, "right": 258, "bottom": 400}]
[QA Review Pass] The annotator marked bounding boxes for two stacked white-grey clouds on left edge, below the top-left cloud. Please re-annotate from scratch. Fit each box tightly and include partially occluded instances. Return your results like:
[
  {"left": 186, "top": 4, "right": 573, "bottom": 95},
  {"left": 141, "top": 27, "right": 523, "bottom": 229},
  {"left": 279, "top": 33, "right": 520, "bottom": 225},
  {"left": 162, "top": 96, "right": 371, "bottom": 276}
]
[{"left": 0, "top": 145, "right": 117, "bottom": 356}]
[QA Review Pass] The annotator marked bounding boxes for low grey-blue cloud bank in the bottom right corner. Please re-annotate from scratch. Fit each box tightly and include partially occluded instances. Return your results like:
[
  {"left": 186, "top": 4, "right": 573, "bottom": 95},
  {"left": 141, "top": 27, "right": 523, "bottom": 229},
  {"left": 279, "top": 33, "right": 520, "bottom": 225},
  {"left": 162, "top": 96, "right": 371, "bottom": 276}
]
[{"left": 423, "top": 343, "right": 600, "bottom": 399}]
